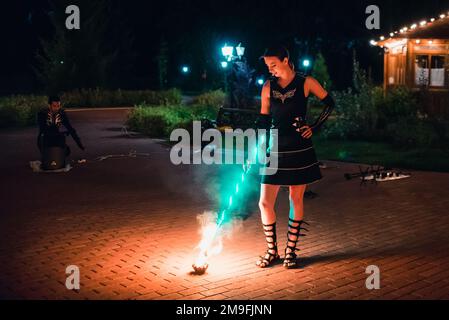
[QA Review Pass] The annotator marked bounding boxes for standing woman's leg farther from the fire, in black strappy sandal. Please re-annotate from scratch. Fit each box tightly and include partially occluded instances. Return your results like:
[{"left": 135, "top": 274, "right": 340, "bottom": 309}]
[{"left": 284, "top": 185, "right": 307, "bottom": 268}]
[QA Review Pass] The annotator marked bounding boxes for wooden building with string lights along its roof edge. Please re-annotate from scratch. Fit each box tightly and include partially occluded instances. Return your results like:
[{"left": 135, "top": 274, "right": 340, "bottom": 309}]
[{"left": 371, "top": 12, "right": 449, "bottom": 115}]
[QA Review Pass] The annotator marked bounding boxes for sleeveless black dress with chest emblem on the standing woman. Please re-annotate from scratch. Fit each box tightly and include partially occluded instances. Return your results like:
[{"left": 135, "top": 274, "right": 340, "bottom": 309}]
[{"left": 261, "top": 74, "right": 323, "bottom": 186}]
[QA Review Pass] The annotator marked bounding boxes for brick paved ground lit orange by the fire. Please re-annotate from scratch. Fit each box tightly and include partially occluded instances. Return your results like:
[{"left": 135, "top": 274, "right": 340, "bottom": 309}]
[{"left": 0, "top": 111, "right": 449, "bottom": 300}]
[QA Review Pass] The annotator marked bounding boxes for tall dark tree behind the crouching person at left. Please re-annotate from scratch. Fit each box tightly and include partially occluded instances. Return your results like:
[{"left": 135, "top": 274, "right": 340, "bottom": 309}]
[{"left": 35, "top": 0, "right": 116, "bottom": 93}]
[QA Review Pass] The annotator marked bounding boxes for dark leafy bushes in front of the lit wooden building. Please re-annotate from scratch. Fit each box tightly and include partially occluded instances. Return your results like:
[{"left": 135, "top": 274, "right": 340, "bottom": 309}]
[{"left": 323, "top": 87, "right": 449, "bottom": 148}]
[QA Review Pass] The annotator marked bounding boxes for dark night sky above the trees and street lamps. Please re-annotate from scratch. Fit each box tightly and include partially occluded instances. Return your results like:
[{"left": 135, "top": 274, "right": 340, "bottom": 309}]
[{"left": 0, "top": 0, "right": 449, "bottom": 95}]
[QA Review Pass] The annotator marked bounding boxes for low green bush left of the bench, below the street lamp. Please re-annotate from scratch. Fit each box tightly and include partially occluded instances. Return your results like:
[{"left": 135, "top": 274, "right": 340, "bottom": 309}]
[{"left": 127, "top": 105, "right": 219, "bottom": 138}]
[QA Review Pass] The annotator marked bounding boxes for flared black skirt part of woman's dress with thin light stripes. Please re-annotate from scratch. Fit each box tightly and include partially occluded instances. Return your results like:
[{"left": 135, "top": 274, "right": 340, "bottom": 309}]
[{"left": 261, "top": 132, "right": 323, "bottom": 186}]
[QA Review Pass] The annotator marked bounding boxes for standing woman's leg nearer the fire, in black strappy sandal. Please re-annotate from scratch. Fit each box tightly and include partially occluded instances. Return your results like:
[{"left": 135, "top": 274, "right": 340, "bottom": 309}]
[{"left": 256, "top": 184, "right": 280, "bottom": 268}]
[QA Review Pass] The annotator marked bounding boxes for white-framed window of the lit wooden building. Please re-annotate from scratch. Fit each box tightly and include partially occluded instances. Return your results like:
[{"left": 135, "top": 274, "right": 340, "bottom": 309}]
[{"left": 415, "top": 55, "right": 446, "bottom": 87}]
